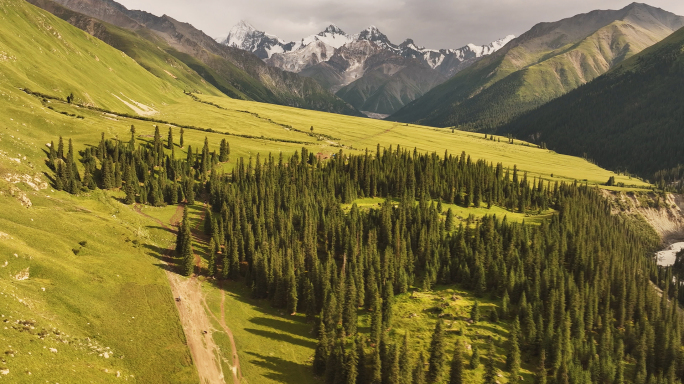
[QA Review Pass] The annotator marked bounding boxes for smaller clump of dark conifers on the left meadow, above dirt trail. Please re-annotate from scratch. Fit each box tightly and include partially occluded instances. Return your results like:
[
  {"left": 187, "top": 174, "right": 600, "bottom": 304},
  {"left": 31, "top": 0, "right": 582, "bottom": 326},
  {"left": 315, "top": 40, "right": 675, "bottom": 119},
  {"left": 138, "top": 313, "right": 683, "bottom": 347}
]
[{"left": 48, "top": 126, "right": 224, "bottom": 206}]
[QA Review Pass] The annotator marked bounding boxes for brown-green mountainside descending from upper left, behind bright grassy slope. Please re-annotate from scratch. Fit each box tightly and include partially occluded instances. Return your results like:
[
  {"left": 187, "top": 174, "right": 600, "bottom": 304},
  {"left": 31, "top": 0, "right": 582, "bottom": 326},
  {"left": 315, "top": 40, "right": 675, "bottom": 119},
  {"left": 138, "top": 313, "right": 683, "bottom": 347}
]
[{"left": 28, "top": 0, "right": 361, "bottom": 116}]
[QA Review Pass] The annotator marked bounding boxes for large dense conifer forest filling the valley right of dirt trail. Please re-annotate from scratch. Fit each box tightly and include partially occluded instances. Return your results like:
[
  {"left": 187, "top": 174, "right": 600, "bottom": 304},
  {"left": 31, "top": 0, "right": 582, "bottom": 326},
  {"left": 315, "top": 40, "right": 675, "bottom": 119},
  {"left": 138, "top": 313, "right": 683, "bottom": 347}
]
[{"left": 49, "top": 131, "right": 684, "bottom": 384}]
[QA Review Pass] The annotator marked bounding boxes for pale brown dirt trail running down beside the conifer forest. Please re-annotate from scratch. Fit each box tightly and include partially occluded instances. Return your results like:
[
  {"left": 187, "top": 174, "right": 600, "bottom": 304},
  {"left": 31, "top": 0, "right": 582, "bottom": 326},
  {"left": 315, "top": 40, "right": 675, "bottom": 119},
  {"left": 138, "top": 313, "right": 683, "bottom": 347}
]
[{"left": 135, "top": 205, "right": 240, "bottom": 384}]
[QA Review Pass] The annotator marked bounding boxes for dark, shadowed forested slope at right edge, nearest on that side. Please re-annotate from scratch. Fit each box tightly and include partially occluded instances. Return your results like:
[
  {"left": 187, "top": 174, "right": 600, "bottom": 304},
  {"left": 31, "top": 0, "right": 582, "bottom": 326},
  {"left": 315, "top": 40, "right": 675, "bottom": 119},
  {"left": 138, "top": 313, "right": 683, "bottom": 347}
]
[{"left": 501, "top": 24, "right": 684, "bottom": 179}]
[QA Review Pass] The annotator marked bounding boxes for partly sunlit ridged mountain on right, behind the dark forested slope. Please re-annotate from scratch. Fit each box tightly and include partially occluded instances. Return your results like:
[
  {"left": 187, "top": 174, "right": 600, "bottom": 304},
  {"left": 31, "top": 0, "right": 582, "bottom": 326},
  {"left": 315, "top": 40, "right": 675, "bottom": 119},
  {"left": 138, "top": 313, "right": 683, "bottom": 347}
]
[{"left": 390, "top": 3, "right": 684, "bottom": 131}]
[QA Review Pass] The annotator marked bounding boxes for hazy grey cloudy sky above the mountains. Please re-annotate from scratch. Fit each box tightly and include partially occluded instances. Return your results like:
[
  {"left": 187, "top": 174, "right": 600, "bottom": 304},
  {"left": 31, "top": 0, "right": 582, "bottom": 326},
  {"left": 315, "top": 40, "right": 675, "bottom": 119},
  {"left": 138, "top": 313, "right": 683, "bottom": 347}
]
[{"left": 117, "top": 0, "right": 684, "bottom": 48}]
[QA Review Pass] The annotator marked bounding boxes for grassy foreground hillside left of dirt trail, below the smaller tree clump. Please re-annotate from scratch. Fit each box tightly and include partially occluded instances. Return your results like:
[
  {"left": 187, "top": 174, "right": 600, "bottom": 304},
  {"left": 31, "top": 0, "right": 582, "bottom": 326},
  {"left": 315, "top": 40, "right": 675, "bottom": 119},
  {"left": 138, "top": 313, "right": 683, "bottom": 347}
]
[{"left": 0, "top": 189, "right": 197, "bottom": 383}]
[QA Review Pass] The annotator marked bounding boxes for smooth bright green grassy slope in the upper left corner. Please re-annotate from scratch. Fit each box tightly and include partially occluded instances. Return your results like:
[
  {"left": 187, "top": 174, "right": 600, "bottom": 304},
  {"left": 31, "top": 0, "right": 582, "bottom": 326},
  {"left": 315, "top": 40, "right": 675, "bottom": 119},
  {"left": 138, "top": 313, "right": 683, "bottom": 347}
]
[{"left": 0, "top": 0, "right": 183, "bottom": 113}]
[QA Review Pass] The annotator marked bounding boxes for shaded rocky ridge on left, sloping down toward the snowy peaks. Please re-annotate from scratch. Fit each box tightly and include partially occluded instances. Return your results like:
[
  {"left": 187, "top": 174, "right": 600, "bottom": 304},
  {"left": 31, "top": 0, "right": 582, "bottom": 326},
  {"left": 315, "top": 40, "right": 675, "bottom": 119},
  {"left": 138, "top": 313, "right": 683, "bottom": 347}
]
[{"left": 32, "top": 0, "right": 359, "bottom": 115}]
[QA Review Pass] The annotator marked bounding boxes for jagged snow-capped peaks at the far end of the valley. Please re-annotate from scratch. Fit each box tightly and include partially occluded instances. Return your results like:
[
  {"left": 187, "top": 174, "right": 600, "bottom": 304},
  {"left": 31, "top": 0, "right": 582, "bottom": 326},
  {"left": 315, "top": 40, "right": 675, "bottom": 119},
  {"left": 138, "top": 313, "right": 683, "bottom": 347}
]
[{"left": 222, "top": 21, "right": 514, "bottom": 115}]
